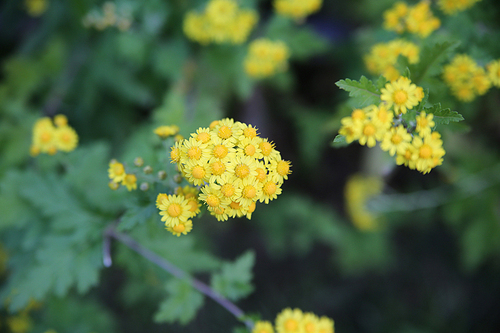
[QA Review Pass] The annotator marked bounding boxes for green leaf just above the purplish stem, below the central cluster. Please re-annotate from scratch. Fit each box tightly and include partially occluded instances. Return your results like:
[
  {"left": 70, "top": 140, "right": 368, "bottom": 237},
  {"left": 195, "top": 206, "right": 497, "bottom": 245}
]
[{"left": 211, "top": 251, "right": 255, "bottom": 301}]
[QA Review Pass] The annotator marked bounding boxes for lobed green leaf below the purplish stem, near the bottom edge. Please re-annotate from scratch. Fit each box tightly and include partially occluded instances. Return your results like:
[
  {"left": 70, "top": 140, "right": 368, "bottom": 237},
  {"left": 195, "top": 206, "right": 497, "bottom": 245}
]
[{"left": 154, "top": 279, "right": 204, "bottom": 325}]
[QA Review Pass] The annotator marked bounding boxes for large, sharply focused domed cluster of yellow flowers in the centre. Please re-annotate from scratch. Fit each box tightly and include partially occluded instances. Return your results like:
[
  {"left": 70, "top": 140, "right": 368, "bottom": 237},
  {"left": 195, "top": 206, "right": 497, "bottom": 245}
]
[{"left": 167, "top": 118, "right": 291, "bottom": 221}]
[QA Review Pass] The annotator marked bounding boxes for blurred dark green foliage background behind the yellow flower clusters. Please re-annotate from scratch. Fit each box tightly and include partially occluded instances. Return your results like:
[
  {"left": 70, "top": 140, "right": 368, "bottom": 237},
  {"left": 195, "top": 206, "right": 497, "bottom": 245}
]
[{"left": 0, "top": 0, "right": 500, "bottom": 333}]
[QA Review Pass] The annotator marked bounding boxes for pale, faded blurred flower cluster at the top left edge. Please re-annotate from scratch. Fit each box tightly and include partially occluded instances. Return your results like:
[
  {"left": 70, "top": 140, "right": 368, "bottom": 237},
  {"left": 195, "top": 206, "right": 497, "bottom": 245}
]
[{"left": 82, "top": 1, "right": 132, "bottom": 31}]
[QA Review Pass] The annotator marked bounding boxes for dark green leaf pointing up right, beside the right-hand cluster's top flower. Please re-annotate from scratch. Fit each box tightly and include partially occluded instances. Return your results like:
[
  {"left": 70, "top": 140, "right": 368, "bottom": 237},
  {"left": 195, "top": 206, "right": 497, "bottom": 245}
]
[{"left": 409, "top": 42, "right": 459, "bottom": 85}]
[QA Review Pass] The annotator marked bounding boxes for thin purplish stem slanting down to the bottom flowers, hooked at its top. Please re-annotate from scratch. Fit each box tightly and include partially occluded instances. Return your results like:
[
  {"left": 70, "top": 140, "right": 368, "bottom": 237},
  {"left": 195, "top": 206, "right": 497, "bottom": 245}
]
[{"left": 104, "top": 224, "right": 253, "bottom": 330}]
